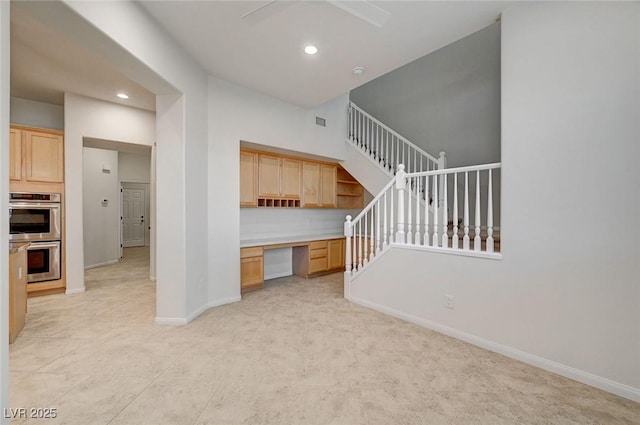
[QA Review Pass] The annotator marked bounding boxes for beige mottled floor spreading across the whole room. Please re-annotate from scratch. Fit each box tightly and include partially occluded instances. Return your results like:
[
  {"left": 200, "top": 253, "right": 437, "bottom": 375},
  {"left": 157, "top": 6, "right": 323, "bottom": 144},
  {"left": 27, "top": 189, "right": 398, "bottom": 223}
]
[{"left": 10, "top": 248, "right": 640, "bottom": 425}]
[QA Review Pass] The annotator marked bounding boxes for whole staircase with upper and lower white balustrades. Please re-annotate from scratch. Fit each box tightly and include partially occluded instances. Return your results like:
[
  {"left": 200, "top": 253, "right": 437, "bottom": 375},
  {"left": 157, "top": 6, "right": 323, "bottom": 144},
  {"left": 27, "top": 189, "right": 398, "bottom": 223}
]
[{"left": 343, "top": 103, "right": 501, "bottom": 284}]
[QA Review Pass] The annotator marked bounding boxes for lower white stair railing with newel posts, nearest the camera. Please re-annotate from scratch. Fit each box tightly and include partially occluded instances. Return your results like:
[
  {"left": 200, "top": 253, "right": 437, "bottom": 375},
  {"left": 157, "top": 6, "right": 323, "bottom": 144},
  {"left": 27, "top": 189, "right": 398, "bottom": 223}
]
[{"left": 344, "top": 163, "right": 501, "bottom": 275}]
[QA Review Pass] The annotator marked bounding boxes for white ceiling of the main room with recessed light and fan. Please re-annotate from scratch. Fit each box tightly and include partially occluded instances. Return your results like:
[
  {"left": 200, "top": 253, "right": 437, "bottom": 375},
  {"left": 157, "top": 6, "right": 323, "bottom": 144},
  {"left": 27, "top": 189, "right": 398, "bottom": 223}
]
[{"left": 141, "top": 1, "right": 508, "bottom": 107}]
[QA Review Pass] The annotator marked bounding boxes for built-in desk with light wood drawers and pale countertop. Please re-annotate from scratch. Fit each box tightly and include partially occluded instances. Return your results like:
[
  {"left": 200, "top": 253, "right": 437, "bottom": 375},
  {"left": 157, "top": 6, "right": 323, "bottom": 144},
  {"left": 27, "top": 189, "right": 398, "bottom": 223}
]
[{"left": 240, "top": 234, "right": 345, "bottom": 292}]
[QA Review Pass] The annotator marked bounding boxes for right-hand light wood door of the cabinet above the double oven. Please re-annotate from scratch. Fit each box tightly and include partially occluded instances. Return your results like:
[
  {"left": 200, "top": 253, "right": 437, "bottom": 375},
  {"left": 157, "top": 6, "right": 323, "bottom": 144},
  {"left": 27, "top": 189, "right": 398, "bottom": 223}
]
[{"left": 22, "top": 131, "right": 64, "bottom": 183}]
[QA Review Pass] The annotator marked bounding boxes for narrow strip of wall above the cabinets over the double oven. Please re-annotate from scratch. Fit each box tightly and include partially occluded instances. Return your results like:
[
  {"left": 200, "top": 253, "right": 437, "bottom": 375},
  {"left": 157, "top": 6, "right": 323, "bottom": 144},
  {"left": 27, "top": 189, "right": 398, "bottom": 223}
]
[{"left": 11, "top": 97, "right": 64, "bottom": 130}]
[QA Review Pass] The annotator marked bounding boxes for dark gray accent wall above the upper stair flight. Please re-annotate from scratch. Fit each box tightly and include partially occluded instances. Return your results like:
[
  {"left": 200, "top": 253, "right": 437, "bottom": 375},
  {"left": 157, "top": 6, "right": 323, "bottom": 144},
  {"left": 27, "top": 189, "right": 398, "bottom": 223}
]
[{"left": 350, "top": 24, "right": 500, "bottom": 167}]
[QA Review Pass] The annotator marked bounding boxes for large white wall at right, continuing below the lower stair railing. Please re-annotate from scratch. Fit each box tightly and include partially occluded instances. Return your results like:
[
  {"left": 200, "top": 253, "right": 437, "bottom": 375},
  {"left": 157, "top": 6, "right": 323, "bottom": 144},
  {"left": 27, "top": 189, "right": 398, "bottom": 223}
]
[{"left": 352, "top": 2, "right": 640, "bottom": 401}]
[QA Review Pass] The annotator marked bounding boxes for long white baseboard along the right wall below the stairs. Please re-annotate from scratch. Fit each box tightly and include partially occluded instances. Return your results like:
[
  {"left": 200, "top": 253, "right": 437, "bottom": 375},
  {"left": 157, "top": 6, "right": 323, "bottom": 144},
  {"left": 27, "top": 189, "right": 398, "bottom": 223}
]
[{"left": 349, "top": 297, "right": 640, "bottom": 402}]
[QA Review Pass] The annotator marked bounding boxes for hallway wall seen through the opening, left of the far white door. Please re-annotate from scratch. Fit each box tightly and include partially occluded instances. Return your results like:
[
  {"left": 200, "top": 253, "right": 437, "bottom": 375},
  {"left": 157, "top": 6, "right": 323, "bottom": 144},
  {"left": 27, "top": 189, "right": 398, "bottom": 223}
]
[{"left": 82, "top": 147, "right": 120, "bottom": 268}]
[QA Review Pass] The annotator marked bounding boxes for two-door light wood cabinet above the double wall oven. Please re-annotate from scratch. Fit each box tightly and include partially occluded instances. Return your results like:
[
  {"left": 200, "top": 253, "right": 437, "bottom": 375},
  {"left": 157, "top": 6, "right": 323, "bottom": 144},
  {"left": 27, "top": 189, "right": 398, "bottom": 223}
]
[{"left": 9, "top": 127, "right": 64, "bottom": 183}]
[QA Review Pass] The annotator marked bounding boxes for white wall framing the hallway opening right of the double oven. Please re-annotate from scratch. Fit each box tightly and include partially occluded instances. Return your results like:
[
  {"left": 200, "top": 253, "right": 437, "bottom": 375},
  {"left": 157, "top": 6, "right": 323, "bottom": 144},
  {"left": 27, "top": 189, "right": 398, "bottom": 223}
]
[{"left": 65, "top": 93, "right": 155, "bottom": 293}]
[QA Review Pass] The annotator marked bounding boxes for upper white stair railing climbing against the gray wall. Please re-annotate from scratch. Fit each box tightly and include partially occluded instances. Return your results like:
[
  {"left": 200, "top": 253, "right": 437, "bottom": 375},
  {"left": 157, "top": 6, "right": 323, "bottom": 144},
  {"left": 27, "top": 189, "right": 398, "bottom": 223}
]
[{"left": 348, "top": 102, "right": 447, "bottom": 175}]
